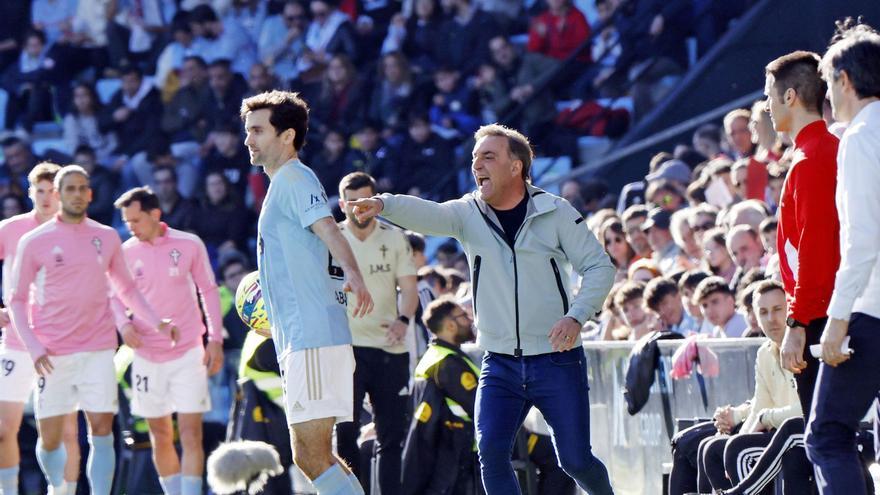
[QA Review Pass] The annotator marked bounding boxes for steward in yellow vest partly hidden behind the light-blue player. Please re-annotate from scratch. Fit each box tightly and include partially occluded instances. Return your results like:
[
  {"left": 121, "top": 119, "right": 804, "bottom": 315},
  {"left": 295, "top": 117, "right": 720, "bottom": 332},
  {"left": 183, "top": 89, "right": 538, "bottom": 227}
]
[{"left": 227, "top": 331, "right": 293, "bottom": 494}]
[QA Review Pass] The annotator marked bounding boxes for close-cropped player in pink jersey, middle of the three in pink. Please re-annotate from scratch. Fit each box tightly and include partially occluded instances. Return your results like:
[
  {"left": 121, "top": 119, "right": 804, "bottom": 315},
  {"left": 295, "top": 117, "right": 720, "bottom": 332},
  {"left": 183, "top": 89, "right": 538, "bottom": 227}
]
[{"left": 7, "top": 165, "right": 177, "bottom": 495}]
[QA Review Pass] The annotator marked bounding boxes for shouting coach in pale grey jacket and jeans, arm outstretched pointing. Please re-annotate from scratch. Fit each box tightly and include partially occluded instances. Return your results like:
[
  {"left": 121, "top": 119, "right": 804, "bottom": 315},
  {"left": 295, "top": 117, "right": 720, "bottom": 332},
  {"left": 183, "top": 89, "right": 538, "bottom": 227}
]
[{"left": 353, "top": 124, "right": 615, "bottom": 495}]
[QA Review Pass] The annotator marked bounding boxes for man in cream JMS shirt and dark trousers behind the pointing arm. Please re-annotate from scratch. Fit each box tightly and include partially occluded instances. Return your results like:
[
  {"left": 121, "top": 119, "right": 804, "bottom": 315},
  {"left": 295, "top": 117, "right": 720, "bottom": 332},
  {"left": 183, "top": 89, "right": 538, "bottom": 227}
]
[{"left": 336, "top": 172, "right": 419, "bottom": 493}]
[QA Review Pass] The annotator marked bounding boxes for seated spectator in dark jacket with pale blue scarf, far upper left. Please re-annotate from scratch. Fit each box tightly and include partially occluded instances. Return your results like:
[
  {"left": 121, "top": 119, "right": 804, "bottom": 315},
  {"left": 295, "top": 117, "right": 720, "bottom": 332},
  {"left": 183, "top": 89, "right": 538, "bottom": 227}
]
[{"left": 0, "top": 31, "right": 57, "bottom": 132}]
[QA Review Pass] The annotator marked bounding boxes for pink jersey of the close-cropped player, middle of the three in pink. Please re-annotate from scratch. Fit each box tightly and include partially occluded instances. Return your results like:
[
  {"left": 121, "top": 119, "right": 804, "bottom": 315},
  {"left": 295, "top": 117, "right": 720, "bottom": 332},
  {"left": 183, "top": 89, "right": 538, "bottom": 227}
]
[{"left": 7, "top": 217, "right": 160, "bottom": 359}]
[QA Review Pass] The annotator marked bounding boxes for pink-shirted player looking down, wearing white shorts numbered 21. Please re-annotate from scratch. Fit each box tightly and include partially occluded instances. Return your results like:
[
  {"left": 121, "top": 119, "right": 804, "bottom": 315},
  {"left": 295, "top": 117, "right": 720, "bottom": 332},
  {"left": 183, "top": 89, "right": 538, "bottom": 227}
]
[{"left": 115, "top": 187, "right": 223, "bottom": 495}]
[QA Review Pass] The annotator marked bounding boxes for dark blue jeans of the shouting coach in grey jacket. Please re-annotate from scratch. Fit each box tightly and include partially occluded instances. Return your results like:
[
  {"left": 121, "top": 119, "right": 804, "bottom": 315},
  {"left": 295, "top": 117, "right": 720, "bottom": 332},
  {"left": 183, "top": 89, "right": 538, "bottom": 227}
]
[{"left": 476, "top": 347, "right": 613, "bottom": 495}]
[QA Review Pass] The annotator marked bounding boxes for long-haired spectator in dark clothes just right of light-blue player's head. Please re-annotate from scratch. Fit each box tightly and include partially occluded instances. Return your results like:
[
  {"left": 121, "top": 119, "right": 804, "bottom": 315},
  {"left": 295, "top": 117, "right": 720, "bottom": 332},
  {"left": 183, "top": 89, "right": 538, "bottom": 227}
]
[{"left": 308, "top": 54, "right": 366, "bottom": 135}]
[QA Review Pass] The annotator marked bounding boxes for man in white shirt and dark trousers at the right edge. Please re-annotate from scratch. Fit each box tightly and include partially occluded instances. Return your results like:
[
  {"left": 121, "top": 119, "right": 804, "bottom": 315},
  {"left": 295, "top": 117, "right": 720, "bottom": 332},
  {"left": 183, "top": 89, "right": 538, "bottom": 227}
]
[{"left": 807, "top": 20, "right": 880, "bottom": 495}]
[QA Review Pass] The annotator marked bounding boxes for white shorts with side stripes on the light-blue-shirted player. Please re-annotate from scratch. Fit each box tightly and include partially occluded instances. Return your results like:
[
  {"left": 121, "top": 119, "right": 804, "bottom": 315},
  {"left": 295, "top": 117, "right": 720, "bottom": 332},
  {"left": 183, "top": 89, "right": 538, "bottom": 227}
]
[{"left": 278, "top": 344, "right": 354, "bottom": 424}]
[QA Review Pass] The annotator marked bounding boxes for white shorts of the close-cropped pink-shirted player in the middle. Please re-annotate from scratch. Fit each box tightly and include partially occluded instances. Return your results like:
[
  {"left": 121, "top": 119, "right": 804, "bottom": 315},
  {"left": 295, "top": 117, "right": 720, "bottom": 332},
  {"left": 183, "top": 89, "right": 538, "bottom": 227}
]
[{"left": 34, "top": 349, "right": 119, "bottom": 419}]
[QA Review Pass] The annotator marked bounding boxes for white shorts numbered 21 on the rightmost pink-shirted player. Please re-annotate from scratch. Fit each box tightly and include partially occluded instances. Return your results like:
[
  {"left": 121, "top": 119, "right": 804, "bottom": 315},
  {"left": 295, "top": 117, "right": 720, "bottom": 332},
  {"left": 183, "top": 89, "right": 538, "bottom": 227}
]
[{"left": 131, "top": 346, "right": 211, "bottom": 418}]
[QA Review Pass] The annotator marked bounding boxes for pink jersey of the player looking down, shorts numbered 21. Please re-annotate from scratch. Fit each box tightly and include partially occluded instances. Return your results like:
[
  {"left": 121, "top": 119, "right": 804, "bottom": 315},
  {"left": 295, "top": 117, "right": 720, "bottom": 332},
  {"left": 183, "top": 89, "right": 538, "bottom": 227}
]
[{"left": 122, "top": 224, "right": 223, "bottom": 362}]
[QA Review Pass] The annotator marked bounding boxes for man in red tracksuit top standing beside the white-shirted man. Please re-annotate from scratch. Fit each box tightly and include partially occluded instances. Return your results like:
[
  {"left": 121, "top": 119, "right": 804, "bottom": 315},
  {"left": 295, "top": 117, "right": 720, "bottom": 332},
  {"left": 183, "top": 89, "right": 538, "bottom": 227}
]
[{"left": 764, "top": 51, "right": 840, "bottom": 419}]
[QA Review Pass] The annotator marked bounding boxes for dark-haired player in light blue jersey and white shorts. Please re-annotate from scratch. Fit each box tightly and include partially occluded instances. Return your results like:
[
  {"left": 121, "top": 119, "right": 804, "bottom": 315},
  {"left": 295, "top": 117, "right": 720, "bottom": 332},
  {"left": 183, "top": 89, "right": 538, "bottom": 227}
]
[{"left": 241, "top": 91, "right": 373, "bottom": 495}]
